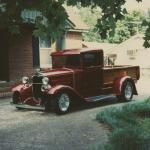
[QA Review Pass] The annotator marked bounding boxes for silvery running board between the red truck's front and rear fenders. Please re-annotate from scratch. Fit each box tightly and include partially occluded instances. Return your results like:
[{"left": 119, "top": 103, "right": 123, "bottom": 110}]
[{"left": 85, "top": 95, "right": 114, "bottom": 102}]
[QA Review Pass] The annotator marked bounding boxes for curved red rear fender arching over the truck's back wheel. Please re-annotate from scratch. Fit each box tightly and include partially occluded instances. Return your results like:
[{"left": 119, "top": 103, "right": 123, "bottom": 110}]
[{"left": 114, "top": 76, "right": 138, "bottom": 95}]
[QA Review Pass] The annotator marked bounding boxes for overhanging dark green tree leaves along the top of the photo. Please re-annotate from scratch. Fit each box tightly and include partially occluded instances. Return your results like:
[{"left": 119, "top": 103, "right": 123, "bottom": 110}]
[{"left": 0, "top": 0, "right": 150, "bottom": 47}]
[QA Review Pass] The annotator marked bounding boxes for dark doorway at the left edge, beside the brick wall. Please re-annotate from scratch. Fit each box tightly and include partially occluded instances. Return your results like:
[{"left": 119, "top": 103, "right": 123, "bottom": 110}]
[{"left": 0, "top": 31, "right": 9, "bottom": 81}]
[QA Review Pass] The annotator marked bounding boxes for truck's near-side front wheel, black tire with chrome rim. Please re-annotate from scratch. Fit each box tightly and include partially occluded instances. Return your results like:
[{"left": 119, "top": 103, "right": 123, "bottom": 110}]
[{"left": 51, "top": 92, "right": 71, "bottom": 114}]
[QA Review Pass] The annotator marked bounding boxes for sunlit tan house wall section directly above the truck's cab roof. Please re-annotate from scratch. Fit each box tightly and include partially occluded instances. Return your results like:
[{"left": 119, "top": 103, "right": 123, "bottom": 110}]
[{"left": 65, "top": 31, "right": 82, "bottom": 49}]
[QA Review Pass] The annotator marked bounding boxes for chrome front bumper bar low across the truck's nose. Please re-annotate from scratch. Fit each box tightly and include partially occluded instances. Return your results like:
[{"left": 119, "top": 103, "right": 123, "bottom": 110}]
[{"left": 11, "top": 102, "right": 45, "bottom": 111}]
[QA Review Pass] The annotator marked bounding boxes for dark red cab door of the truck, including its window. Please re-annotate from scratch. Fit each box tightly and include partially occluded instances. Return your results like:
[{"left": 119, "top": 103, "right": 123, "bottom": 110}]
[{"left": 83, "top": 52, "right": 102, "bottom": 97}]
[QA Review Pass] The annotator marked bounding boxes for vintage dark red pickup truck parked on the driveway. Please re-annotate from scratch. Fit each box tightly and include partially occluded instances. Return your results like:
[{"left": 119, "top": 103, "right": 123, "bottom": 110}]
[{"left": 12, "top": 49, "right": 140, "bottom": 114}]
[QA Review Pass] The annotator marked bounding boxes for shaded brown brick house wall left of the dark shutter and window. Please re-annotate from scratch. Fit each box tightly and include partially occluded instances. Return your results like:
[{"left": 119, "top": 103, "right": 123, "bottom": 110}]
[{"left": 9, "top": 28, "right": 34, "bottom": 80}]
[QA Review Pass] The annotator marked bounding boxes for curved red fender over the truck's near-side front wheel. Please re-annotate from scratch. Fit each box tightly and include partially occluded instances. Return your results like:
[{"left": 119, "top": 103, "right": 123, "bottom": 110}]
[{"left": 48, "top": 85, "right": 82, "bottom": 98}]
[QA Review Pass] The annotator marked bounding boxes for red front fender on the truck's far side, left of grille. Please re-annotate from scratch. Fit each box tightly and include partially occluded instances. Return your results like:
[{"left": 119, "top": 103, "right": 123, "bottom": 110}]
[{"left": 12, "top": 84, "right": 33, "bottom": 101}]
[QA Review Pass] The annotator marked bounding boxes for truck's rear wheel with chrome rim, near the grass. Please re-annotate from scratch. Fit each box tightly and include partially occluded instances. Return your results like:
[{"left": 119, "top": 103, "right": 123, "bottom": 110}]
[{"left": 117, "top": 81, "right": 133, "bottom": 101}]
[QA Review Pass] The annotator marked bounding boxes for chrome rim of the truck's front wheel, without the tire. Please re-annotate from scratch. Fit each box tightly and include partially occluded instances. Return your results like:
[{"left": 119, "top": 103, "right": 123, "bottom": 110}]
[{"left": 58, "top": 93, "right": 70, "bottom": 112}]
